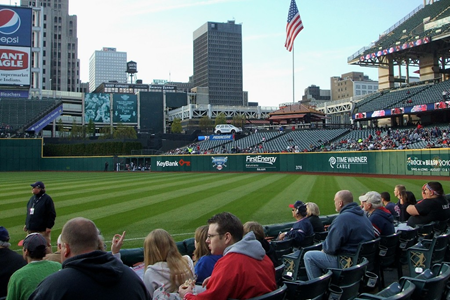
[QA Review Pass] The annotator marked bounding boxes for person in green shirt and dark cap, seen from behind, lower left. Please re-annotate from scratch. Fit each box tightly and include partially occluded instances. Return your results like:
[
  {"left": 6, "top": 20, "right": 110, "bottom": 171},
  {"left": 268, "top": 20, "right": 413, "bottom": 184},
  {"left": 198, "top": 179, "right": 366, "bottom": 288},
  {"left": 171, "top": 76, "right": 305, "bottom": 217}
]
[{"left": 6, "top": 232, "right": 61, "bottom": 300}]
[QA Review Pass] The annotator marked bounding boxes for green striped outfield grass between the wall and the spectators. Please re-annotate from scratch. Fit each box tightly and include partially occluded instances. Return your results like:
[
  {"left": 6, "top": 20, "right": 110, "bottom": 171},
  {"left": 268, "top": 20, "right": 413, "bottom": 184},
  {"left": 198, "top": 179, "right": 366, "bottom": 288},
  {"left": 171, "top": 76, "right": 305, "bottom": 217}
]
[{"left": 0, "top": 172, "right": 450, "bottom": 249}]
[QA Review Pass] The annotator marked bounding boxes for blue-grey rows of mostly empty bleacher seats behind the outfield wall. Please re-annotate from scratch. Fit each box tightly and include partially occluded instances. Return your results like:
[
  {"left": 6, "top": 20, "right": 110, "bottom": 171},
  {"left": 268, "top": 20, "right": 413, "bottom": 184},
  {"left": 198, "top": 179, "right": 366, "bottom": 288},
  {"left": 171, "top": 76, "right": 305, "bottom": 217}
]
[{"left": 168, "top": 124, "right": 450, "bottom": 154}]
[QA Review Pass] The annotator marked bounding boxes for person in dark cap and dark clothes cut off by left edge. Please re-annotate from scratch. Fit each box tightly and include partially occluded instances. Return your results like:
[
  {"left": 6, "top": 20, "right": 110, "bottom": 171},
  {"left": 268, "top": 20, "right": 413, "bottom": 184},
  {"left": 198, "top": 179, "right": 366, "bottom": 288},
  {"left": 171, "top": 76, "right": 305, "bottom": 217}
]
[{"left": 0, "top": 226, "right": 27, "bottom": 297}]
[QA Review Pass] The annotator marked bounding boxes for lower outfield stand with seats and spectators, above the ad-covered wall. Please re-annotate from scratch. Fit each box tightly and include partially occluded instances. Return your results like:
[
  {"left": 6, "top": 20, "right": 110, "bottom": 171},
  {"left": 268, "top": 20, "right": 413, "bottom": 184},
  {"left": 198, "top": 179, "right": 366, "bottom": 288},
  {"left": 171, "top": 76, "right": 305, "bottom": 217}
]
[{"left": 165, "top": 124, "right": 450, "bottom": 155}]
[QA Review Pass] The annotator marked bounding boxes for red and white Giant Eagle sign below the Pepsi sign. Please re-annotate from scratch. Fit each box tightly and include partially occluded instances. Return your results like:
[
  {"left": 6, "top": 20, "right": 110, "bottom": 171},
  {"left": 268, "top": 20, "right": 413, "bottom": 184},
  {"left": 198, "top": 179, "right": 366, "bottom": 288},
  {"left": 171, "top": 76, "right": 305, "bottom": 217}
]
[{"left": 0, "top": 46, "right": 31, "bottom": 85}]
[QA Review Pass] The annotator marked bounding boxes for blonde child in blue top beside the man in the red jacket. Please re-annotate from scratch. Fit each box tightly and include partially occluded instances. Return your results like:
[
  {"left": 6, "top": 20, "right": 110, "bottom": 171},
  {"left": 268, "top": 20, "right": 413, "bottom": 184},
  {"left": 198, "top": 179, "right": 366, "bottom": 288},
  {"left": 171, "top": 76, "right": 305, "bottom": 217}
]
[{"left": 194, "top": 225, "right": 222, "bottom": 284}]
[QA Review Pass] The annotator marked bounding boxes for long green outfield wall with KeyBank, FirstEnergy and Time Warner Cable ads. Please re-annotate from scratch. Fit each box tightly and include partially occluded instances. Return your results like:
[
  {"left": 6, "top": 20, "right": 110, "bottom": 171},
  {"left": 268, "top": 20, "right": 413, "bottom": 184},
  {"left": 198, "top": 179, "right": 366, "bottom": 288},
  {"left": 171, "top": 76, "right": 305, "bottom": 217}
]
[{"left": 152, "top": 149, "right": 450, "bottom": 176}]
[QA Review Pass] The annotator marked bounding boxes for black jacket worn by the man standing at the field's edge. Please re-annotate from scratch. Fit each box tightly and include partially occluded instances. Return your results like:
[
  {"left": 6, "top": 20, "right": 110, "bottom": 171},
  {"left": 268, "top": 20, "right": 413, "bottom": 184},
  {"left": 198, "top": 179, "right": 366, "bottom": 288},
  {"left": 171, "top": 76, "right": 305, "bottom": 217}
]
[{"left": 25, "top": 194, "right": 56, "bottom": 231}]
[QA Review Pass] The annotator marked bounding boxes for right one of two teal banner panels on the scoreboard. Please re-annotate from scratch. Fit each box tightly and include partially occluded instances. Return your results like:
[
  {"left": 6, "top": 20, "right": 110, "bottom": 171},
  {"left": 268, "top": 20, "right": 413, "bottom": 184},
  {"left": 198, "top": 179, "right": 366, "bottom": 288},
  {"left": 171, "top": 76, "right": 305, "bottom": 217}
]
[{"left": 113, "top": 94, "right": 137, "bottom": 123}]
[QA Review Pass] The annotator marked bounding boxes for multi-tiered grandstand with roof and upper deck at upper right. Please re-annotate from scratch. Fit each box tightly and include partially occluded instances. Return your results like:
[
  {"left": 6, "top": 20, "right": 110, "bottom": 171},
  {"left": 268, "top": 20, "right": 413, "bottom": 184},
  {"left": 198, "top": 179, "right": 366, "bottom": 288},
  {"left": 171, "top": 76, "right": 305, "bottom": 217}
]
[{"left": 317, "top": 0, "right": 450, "bottom": 127}]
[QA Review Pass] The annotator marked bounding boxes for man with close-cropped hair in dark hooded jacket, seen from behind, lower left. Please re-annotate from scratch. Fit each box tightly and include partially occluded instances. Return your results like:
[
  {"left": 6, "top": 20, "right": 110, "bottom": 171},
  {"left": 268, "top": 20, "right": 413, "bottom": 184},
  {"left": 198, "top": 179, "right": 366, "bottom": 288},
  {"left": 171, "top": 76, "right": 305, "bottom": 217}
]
[{"left": 29, "top": 218, "right": 151, "bottom": 300}]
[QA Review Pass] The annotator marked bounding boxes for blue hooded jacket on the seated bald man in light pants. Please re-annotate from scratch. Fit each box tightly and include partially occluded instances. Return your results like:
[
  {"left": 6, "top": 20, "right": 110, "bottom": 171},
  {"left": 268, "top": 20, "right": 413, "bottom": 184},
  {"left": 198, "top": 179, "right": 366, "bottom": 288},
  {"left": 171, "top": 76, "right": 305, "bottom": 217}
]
[{"left": 322, "top": 202, "right": 375, "bottom": 255}]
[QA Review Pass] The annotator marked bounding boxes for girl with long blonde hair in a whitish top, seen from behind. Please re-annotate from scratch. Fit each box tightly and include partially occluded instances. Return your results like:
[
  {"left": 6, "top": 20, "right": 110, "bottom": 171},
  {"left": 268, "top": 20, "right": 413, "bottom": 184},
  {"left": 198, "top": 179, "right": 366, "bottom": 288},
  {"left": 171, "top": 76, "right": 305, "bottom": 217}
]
[{"left": 144, "top": 229, "right": 194, "bottom": 298}]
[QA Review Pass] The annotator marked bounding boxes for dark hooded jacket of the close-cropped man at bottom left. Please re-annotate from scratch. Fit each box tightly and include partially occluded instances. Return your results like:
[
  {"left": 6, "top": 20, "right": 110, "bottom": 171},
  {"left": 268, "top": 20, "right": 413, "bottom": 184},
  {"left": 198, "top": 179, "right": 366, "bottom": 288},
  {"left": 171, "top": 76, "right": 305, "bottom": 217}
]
[{"left": 28, "top": 251, "right": 151, "bottom": 300}]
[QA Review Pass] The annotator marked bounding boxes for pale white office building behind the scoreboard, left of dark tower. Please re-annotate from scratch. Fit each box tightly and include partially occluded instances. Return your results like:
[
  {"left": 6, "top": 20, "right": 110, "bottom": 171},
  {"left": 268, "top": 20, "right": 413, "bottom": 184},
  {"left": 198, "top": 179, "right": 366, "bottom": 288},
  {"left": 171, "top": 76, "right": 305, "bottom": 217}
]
[{"left": 89, "top": 47, "right": 127, "bottom": 92}]
